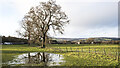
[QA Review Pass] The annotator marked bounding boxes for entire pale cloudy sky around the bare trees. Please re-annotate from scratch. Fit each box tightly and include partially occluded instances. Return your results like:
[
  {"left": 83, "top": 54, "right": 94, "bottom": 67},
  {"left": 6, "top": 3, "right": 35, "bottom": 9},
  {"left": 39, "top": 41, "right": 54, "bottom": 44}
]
[{"left": 0, "top": 0, "right": 118, "bottom": 38}]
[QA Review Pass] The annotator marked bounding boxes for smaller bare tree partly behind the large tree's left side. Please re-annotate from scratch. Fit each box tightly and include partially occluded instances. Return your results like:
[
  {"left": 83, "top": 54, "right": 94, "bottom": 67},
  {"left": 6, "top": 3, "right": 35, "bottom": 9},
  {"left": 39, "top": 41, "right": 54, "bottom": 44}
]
[{"left": 17, "top": 9, "right": 36, "bottom": 45}]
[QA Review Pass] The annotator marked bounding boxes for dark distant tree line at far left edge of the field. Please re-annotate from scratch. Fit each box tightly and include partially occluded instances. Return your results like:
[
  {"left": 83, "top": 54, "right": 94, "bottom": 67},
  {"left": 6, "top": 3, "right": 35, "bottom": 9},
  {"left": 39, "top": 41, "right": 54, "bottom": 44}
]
[{"left": 2, "top": 36, "right": 28, "bottom": 44}]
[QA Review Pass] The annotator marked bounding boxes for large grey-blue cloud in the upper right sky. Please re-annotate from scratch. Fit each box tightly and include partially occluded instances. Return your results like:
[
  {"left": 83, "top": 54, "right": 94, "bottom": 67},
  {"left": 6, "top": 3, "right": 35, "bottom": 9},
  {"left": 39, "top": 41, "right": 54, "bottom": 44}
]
[{"left": 69, "top": 2, "right": 118, "bottom": 27}]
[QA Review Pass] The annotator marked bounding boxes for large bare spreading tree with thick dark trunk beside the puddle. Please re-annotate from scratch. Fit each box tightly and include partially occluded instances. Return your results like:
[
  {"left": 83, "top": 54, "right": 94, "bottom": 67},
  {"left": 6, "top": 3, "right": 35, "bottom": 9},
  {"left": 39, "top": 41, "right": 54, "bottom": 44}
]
[{"left": 34, "top": 0, "right": 69, "bottom": 48}]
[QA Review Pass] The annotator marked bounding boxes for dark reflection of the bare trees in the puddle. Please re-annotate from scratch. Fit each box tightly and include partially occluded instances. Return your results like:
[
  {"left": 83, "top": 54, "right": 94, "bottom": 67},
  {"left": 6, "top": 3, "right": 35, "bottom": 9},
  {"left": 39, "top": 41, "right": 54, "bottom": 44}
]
[{"left": 27, "top": 52, "right": 52, "bottom": 65}]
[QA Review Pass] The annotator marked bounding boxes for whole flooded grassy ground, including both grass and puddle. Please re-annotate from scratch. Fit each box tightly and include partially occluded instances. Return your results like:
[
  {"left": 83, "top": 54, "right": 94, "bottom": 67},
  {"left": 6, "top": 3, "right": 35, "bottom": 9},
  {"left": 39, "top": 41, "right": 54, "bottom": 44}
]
[{"left": 2, "top": 44, "right": 120, "bottom": 66}]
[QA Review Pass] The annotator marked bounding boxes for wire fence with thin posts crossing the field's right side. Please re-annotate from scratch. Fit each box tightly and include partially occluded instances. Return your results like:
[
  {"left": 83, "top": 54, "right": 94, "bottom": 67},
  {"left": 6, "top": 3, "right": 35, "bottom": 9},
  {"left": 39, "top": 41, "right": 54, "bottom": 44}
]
[{"left": 49, "top": 47, "right": 120, "bottom": 59}]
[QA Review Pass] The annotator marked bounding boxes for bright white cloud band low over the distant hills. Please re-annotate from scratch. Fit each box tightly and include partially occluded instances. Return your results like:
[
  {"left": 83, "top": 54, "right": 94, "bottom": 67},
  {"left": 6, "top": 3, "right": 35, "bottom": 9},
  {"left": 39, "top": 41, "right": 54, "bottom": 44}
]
[{"left": 54, "top": 27, "right": 118, "bottom": 38}]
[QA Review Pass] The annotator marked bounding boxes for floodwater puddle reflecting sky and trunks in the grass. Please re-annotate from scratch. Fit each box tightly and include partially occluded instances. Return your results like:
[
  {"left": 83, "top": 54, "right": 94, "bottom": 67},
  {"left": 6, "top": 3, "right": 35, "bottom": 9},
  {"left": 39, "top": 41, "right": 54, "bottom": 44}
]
[{"left": 5, "top": 52, "right": 65, "bottom": 66}]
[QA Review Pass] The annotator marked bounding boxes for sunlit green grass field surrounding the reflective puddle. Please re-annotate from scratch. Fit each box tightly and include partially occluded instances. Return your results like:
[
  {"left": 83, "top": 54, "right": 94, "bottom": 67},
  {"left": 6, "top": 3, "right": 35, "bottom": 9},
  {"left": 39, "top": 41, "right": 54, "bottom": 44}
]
[{"left": 2, "top": 44, "right": 119, "bottom": 66}]
